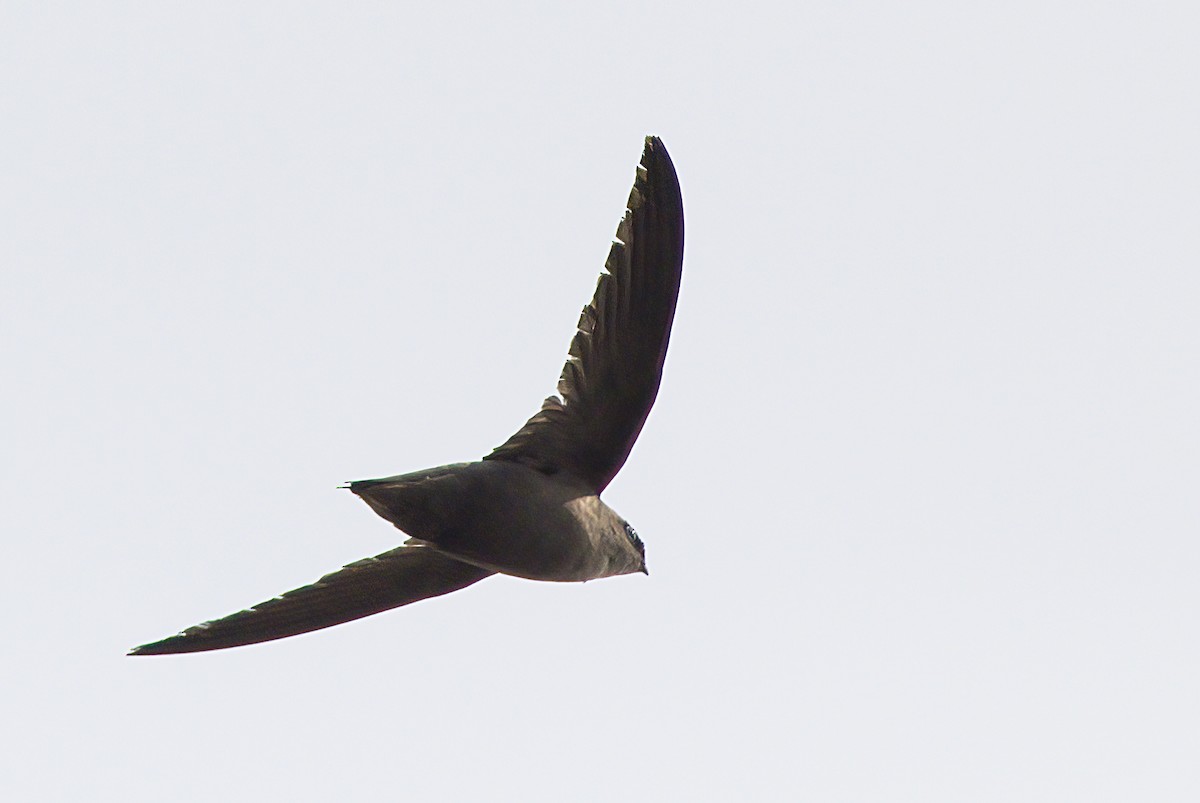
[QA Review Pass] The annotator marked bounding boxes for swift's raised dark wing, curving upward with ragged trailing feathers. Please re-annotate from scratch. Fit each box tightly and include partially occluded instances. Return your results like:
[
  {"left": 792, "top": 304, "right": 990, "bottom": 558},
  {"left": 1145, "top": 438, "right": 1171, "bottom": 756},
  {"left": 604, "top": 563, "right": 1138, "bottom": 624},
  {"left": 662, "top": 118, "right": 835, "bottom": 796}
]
[{"left": 485, "top": 137, "right": 683, "bottom": 492}]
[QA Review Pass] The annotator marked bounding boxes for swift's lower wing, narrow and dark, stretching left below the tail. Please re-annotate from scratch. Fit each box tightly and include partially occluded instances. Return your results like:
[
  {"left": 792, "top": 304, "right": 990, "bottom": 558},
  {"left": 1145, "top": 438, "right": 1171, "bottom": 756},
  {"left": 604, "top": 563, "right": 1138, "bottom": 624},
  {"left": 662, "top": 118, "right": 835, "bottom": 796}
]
[{"left": 130, "top": 546, "right": 494, "bottom": 655}]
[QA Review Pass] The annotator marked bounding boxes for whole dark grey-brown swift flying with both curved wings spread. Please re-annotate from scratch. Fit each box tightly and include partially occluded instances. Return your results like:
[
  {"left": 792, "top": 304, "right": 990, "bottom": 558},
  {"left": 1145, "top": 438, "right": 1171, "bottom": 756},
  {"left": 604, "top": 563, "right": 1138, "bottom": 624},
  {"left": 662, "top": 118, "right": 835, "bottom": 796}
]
[{"left": 130, "top": 137, "right": 683, "bottom": 655}]
